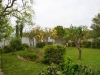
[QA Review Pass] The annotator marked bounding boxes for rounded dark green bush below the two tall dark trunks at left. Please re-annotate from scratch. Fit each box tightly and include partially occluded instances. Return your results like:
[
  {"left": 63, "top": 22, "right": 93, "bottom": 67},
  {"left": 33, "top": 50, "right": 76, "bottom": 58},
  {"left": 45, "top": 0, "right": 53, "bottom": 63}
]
[{"left": 10, "top": 37, "right": 22, "bottom": 51}]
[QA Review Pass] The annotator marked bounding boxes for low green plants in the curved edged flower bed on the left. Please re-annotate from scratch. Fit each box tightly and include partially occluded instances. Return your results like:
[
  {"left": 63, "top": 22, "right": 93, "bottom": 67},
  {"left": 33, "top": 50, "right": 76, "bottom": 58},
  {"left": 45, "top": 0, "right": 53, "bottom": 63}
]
[{"left": 20, "top": 51, "right": 38, "bottom": 61}]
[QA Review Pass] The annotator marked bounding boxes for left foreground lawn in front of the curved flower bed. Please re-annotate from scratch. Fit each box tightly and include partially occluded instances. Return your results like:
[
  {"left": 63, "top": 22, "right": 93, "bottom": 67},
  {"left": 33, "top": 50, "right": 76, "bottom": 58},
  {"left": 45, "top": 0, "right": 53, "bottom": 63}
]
[{"left": 1, "top": 52, "right": 46, "bottom": 75}]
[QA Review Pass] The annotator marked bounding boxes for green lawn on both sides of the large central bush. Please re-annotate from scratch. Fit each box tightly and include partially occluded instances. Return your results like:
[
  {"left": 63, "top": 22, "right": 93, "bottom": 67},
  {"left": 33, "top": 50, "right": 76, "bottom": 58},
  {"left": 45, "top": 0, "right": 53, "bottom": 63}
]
[{"left": 1, "top": 47, "right": 100, "bottom": 75}]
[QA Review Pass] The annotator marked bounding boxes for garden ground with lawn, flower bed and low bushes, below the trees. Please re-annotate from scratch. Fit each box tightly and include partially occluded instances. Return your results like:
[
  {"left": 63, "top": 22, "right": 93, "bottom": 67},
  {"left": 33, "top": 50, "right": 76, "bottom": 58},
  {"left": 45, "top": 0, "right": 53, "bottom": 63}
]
[{"left": 1, "top": 38, "right": 100, "bottom": 75}]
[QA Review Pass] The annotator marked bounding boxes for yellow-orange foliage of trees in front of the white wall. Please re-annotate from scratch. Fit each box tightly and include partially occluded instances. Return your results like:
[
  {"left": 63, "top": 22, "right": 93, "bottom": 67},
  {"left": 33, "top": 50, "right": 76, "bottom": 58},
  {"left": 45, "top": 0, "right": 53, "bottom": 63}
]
[{"left": 28, "top": 26, "right": 57, "bottom": 43}]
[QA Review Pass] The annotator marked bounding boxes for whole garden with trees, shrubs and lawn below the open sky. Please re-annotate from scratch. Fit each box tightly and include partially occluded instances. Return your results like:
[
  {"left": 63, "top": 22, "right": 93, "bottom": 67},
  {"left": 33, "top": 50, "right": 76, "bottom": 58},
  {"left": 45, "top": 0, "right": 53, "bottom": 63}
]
[{"left": 0, "top": 0, "right": 100, "bottom": 75}]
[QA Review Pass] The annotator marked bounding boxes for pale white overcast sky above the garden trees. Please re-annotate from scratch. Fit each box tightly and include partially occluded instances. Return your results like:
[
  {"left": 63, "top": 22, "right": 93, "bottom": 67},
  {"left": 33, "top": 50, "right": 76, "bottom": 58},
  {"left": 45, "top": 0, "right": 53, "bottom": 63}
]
[{"left": 33, "top": 0, "right": 100, "bottom": 28}]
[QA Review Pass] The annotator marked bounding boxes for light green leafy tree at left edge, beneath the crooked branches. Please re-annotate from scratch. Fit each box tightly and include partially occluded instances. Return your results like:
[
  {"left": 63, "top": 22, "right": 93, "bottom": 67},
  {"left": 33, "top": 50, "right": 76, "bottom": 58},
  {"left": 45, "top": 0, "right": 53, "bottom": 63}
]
[{"left": 0, "top": 17, "right": 13, "bottom": 41}]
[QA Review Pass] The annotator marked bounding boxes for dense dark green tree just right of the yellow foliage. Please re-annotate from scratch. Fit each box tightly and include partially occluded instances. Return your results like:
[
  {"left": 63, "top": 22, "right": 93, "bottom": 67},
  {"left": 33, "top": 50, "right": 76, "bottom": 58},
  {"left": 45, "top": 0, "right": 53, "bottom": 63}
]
[{"left": 54, "top": 26, "right": 65, "bottom": 43}]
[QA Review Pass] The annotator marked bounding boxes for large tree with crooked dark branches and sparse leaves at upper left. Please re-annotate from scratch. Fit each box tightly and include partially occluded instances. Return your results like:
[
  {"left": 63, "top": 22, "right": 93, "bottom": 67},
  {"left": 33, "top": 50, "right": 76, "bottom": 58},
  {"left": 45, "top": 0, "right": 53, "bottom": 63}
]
[{"left": 0, "top": 0, "right": 34, "bottom": 38}]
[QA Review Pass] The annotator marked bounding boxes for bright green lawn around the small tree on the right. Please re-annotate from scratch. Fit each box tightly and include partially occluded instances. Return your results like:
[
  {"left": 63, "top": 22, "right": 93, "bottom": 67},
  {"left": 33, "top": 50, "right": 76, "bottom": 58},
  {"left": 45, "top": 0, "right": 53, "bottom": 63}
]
[{"left": 65, "top": 47, "right": 100, "bottom": 70}]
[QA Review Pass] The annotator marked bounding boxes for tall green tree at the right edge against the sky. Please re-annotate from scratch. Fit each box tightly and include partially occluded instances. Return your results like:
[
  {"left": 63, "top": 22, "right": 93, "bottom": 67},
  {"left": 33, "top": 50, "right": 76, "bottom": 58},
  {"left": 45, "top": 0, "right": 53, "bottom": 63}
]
[{"left": 91, "top": 13, "right": 100, "bottom": 38}]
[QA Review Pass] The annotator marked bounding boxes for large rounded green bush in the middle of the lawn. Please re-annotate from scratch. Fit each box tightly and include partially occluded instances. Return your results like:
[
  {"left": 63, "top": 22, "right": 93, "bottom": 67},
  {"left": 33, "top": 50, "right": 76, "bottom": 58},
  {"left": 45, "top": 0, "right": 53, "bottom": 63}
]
[{"left": 43, "top": 45, "right": 66, "bottom": 64}]
